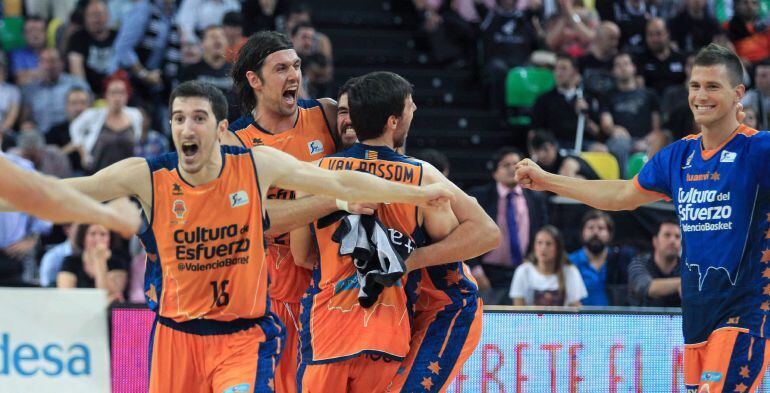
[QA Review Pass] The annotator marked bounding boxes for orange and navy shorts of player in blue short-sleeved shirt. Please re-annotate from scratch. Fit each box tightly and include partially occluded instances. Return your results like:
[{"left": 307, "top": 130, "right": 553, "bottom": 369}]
[{"left": 684, "top": 328, "right": 770, "bottom": 393}]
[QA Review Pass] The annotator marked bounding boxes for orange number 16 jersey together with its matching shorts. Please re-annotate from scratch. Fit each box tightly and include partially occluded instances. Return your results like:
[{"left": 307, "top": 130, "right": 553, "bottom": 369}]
[{"left": 140, "top": 146, "right": 285, "bottom": 393}]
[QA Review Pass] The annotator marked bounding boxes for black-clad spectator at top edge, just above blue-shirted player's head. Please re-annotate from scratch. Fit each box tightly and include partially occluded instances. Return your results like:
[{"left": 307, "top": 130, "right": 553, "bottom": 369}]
[{"left": 668, "top": 0, "right": 722, "bottom": 53}]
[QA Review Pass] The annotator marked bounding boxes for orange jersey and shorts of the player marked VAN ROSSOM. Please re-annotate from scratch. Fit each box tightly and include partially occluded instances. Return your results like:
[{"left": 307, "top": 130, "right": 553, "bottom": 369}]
[{"left": 298, "top": 144, "right": 422, "bottom": 392}]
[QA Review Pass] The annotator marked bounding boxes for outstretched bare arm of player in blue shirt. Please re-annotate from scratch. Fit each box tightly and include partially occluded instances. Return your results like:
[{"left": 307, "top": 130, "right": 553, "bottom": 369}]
[{"left": 516, "top": 158, "right": 661, "bottom": 210}]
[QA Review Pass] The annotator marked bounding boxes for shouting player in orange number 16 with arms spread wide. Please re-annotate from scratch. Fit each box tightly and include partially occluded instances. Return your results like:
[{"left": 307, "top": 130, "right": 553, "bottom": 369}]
[{"left": 9, "top": 82, "right": 452, "bottom": 392}]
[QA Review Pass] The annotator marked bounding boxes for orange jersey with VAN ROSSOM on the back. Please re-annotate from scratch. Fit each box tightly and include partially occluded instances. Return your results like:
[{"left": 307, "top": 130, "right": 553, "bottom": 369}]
[{"left": 300, "top": 144, "right": 422, "bottom": 364}]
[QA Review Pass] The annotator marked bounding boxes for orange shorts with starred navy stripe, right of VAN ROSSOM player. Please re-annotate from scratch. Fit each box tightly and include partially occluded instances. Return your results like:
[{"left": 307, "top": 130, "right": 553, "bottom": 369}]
[{"left": 393, "top": 299, "right": 484, "bottom": 392}]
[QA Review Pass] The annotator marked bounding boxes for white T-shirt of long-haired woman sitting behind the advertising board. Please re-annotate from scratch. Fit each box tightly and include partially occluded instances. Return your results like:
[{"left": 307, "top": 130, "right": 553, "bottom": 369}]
[{"left": 508, "top": 262, "right": 588, "bottom": 306}]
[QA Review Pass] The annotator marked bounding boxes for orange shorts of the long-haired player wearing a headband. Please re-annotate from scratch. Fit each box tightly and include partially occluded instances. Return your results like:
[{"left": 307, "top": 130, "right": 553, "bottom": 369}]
[{"left": 270, "top": 298, "right": 300, "bottom": 393}]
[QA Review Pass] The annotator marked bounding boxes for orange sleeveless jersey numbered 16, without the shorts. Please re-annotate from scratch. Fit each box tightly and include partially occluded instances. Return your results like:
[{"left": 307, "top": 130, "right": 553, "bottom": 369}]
[{"left": 140, "top": 146, "right": 268, "bottom": 322}]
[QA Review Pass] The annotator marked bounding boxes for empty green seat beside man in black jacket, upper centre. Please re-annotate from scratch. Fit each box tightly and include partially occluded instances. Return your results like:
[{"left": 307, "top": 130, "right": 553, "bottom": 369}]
[{"left": 505, "top": 67, "right": 555, "bottom": 126}]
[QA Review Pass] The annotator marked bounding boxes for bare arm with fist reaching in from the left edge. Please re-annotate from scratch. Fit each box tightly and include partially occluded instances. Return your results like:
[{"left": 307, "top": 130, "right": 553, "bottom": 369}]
[{"left": 0, "top": 157, "right": 141, "bottom": 236}]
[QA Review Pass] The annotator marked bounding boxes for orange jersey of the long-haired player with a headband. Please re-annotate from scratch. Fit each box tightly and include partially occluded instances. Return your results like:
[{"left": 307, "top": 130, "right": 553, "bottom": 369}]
[{"left": 231, "top": 100, "right": 336, "bottom": 303}]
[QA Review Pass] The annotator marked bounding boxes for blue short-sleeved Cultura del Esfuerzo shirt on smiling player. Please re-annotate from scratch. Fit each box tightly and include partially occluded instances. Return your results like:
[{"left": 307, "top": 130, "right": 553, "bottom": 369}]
[{"left": 634, "top": 125, "right": 770, "bottom": 344}]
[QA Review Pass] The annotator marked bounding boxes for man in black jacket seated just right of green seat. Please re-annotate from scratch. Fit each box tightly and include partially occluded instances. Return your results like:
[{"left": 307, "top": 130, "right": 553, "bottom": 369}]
[{"left": 532, "top": 55, "right": 601, "bottom": 148}]
